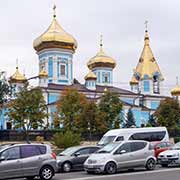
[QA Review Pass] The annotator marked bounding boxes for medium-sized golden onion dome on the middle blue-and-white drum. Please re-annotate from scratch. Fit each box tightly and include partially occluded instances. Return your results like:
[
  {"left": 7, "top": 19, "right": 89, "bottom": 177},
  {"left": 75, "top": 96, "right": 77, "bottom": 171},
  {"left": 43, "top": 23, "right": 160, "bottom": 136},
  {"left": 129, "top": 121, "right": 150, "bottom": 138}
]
[{"left": 87, "top": 36, "right": 116, "bottom": 69}]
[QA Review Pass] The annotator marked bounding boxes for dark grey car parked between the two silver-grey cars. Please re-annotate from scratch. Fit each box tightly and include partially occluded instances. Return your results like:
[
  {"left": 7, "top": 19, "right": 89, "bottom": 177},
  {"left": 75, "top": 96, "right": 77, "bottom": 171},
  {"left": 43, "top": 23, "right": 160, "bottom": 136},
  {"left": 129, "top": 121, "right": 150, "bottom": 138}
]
[{"left": 57, "top": 146, "right": 100, "bottom": 172}]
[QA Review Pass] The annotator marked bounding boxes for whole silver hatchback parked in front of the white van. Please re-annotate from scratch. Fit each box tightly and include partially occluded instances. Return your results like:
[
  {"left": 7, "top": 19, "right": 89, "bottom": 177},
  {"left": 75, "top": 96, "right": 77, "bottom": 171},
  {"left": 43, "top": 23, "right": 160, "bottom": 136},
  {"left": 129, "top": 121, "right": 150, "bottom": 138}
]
[{"left": 84, "top": 140, "right": 156, "bottom": 174}]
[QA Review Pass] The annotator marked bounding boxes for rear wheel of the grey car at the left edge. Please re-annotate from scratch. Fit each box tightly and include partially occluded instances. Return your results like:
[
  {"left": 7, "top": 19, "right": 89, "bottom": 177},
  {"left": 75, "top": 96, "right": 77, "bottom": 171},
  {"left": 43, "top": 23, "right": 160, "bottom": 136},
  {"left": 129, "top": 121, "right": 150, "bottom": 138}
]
[{"left": 39, "top": 166, "right": 54, "bottom": 180}]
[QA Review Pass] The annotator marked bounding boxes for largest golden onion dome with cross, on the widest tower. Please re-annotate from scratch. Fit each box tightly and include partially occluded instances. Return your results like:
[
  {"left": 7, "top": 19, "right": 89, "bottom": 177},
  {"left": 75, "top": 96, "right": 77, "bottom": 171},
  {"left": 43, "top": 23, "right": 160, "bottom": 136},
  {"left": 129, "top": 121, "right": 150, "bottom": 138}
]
[{"left": 33, "top": 6, "right": 77, "bottom": 52}]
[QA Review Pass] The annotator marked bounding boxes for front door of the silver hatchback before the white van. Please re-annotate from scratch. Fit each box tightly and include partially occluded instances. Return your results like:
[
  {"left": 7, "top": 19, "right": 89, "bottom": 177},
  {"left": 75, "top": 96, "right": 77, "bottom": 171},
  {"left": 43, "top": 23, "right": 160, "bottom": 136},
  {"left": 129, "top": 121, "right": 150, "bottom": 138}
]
[{"left": 113, "top": 142, "right": 132, "bottom": 168}]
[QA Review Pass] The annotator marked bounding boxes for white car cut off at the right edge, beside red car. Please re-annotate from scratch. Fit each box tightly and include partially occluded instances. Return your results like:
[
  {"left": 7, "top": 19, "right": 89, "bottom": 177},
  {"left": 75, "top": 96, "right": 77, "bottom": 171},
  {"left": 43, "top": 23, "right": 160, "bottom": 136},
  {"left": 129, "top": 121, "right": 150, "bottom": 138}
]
[{"left": 158, "top": 142, "right": 180, "bottom": 167}]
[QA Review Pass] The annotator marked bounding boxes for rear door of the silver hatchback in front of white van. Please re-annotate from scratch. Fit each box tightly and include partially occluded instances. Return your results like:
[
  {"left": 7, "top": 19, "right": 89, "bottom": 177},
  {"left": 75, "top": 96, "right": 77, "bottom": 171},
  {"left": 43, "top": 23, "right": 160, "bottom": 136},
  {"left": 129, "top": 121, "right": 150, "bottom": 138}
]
[{"left": 130, "top": 142, "right": 149, "bottom": 167}]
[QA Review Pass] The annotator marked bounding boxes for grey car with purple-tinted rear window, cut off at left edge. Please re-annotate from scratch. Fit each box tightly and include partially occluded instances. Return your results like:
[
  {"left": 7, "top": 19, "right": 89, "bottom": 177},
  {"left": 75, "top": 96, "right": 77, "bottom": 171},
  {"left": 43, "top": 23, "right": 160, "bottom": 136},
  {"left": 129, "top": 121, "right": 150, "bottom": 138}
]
[{"left": 0, "top": 144, "right": 57, "bottom": 180}]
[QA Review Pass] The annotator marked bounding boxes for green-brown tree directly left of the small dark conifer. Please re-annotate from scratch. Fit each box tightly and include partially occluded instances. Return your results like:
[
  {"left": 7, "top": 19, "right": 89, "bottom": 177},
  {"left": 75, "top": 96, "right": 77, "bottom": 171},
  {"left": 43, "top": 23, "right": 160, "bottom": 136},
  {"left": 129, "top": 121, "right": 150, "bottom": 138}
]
[{"left": 98, "top": 91, "right": 122, "bottom": 129}]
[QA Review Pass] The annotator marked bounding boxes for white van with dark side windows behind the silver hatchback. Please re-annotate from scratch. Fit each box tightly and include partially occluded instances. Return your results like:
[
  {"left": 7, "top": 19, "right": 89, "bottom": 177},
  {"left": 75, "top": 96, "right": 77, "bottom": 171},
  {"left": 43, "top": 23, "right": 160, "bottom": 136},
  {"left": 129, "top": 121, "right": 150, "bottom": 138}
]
[{"left": 98, "top": 127, "right": 169, "bottom": 146}]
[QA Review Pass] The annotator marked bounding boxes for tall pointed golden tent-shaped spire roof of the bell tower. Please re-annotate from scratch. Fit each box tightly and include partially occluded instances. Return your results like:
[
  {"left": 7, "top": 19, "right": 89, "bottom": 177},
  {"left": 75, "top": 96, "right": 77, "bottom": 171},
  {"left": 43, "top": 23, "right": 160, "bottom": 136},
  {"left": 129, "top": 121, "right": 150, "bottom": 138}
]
[{"left": 135, "top": 30, "right": 164, "bottom": 80}]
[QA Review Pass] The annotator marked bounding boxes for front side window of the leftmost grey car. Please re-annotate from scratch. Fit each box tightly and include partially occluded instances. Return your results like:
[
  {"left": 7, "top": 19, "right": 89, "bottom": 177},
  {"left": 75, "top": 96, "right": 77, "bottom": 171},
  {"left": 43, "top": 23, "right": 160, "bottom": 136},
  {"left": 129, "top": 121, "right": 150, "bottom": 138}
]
[{"left": 1, "top": 147, "right": 20, "bottom": 160}]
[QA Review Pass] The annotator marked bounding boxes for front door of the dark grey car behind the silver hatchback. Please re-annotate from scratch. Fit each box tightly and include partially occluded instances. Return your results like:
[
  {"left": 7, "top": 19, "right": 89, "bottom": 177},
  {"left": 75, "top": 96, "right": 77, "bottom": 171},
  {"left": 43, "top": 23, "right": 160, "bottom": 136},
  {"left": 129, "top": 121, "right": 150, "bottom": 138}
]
[{"left": 72, "top": 148, "right": 90, "bottom": 169}]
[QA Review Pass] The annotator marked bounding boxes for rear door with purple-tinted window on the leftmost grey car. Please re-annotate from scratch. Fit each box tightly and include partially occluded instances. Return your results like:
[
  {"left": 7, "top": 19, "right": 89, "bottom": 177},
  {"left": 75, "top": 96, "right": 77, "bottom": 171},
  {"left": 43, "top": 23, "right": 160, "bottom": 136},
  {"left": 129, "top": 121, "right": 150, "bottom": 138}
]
[{"left": 21, "top": 145, "right": 42, "bottom": 176}]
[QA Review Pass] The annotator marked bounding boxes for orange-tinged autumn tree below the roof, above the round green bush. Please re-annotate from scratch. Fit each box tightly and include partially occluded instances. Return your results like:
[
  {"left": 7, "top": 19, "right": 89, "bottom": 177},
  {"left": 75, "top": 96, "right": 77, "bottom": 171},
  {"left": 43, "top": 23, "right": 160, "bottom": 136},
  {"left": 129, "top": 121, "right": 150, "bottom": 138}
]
[{"left": 55, "top": 88, "right": 87, "bottom": 132}]
